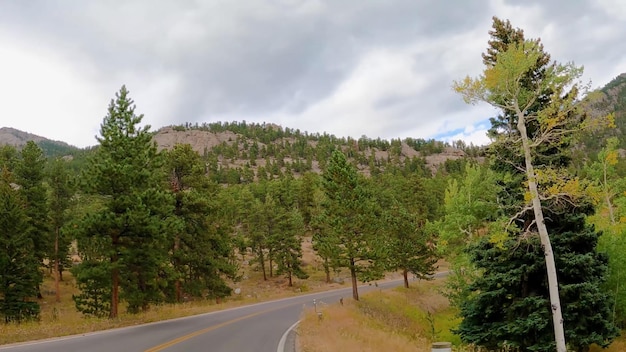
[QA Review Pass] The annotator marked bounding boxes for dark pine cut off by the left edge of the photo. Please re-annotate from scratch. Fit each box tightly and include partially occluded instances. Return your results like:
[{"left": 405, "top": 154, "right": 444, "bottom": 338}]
[{"left": 0, "top": 169, "right": 41, "bottom": 323}]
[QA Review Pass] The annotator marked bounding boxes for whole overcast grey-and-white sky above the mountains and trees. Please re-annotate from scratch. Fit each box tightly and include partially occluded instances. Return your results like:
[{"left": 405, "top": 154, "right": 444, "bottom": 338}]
[{"left": 0, "top": 0, "right": 626, "bottom": 147}]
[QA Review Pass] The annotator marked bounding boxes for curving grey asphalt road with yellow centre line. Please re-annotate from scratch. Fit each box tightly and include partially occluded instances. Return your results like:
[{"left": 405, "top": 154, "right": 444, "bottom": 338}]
[{"left": 0, "top": 280, "right": 436, "bottom": 352}]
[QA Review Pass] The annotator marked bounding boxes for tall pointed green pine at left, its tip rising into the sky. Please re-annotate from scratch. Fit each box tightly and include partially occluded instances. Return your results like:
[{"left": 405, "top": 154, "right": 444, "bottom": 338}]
[{"left": 77, "top": 86, "right": 173, "bottom": 318}]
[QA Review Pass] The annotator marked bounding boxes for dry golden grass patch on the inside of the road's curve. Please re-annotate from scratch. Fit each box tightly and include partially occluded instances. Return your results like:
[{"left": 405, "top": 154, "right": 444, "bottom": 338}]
[{"left": 297, "top": 279, "right": 626, "bottom": 352}]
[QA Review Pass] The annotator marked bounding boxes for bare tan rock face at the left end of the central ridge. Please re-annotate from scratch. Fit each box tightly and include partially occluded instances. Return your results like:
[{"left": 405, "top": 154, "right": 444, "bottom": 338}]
[{"left": 154, "top": 127, "right": 237, "bottom": 155}]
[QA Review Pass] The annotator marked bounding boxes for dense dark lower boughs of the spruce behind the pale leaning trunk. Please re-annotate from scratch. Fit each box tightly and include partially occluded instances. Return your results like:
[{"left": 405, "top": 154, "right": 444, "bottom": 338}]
[{"left": 457, "top": 205, "right": 619, "bottom": 352}]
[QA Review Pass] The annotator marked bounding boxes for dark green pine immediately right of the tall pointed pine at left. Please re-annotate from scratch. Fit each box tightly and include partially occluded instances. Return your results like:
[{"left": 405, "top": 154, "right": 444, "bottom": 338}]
[{"left": 166, "top": 144, "right": 236, "bottom": 302}]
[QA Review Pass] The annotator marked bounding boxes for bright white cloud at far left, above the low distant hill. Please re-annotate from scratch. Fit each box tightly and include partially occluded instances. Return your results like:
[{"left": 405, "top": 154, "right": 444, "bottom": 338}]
[{"left": 0, "top": 36, "right": 106, "bottom": 147}]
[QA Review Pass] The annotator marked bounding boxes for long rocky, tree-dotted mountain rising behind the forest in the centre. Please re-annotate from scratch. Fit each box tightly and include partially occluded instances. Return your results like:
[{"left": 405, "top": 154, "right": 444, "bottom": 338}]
[{"left": 154, "top": 121, "right": 481, "bottom": 182}]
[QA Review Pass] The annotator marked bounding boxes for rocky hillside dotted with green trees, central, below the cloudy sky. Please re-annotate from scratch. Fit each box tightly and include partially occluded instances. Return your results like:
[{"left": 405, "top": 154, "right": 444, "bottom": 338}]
[{"left": 154, "top": 124, "right": 468, "bottom": 174}]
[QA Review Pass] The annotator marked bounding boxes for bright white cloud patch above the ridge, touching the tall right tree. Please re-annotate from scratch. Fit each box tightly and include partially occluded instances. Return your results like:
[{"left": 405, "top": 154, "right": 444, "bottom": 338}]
[{"left": 272, "top": 26, "right": 493, "bottom": 142}]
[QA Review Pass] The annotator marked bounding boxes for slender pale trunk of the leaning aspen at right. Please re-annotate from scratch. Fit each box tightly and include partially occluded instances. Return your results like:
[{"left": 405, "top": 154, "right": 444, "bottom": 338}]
[{"left": 516, "top": 109, "right": 567, "bottom": 352}]
